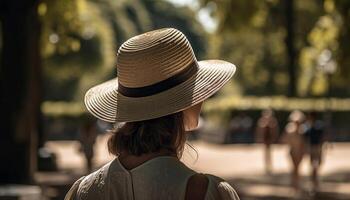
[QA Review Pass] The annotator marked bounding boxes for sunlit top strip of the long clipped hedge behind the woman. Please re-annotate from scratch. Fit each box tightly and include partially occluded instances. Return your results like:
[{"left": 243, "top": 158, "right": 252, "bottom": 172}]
[{"left": 41, "top": 95, "right": 350, "bottom": 117}]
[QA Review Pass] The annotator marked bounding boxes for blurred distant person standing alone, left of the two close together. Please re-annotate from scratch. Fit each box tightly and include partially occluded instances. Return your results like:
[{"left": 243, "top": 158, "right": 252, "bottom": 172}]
[{"left": 255, "top": 109, "right": 279, "bottom": 174}]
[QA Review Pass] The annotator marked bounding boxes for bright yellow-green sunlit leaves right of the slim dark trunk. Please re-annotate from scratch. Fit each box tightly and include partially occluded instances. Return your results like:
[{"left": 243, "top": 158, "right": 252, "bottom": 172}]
[{"left": 299, "top": 0, "right": 342, "bottom": 96}]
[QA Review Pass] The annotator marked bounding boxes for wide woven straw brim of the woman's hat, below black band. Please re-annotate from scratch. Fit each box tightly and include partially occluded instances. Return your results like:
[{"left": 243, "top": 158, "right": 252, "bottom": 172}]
[{"left": 84, "top": 60, "right": 236, "bottom": 123}]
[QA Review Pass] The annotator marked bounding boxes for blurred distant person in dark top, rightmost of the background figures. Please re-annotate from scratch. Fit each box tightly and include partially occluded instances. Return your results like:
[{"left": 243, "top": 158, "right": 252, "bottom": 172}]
[{"left": 304, "top": 112, "right": 326, "bottom": 191}]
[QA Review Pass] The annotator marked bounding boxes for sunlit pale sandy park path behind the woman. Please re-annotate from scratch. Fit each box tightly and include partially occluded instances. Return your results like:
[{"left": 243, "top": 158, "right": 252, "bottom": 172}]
[{"left": 46, "top": 135, "right": 350, "bottom": 199}]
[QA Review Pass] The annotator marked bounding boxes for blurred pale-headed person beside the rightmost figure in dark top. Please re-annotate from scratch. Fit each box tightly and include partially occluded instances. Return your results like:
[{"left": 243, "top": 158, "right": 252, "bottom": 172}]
[{"left": 282, "top": 110, "right": 305, "bottom": 191}]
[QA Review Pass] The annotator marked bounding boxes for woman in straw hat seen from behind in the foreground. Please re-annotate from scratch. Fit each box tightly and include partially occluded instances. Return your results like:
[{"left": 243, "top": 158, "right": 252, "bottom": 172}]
[{"left": 65, "top": 28, "right": 239, "bottom": 200}]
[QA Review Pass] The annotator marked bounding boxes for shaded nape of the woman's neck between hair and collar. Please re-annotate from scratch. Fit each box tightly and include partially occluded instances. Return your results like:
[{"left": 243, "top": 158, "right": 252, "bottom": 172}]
[{"left": 118, "top": 149, "right": 177, "bottom": 170}]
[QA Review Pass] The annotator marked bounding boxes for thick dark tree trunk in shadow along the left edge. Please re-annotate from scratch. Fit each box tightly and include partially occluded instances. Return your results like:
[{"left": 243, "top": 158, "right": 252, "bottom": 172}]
[{"left": 0, "top": 0, "right": 41, "bottom": 183}]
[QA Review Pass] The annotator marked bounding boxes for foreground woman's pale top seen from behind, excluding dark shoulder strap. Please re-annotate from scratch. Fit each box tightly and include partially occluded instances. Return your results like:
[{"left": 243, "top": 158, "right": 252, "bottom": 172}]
[{"left": 65, "top": 156, "right": 239, "bottom": 200}]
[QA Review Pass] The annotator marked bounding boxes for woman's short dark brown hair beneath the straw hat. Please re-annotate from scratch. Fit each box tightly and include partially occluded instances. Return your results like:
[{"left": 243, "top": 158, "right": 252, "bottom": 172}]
[{"left": 108, "top": 112, "right": 186, "bottom": 158}]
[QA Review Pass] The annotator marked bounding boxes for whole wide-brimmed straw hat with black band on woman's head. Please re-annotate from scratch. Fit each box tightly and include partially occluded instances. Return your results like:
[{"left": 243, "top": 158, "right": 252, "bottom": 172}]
[{"left": 85, "top": 28, "right": 236, "bottom": 123}]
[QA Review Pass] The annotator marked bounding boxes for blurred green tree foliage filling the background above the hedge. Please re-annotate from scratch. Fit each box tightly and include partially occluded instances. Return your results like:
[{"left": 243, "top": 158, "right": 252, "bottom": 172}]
[{"left": 38, "top": 0, "right": 350, "bottom": 119}]
